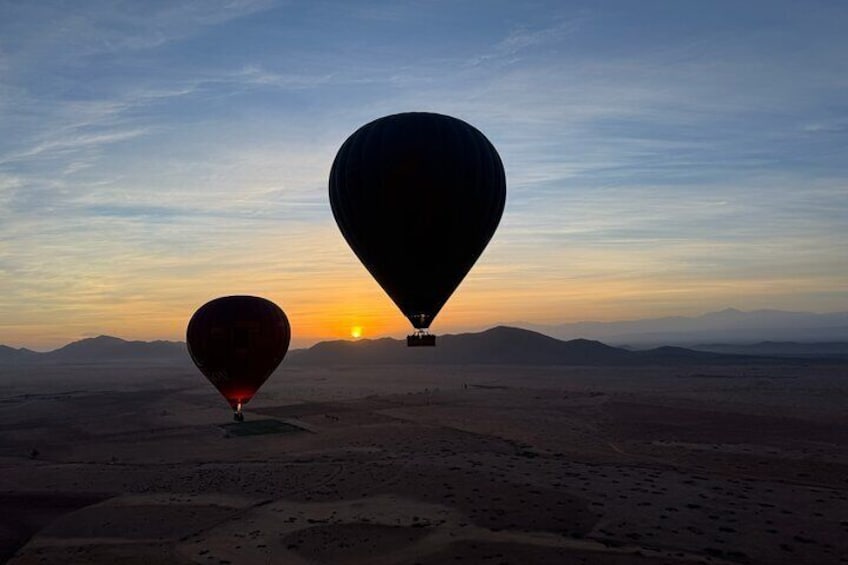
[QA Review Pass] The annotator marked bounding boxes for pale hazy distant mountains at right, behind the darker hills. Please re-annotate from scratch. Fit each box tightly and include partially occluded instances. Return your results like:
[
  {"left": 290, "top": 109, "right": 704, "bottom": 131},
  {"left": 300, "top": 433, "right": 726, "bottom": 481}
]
[{"left": 511, "top": 308, "right": 848, "bottom": 347}]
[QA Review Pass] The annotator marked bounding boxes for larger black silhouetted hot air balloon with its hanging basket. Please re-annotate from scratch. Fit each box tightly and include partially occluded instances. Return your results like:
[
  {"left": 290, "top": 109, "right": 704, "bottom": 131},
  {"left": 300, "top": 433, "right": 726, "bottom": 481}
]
[{"left": 329, "top": 112, "right": 506, "bottom": 345}]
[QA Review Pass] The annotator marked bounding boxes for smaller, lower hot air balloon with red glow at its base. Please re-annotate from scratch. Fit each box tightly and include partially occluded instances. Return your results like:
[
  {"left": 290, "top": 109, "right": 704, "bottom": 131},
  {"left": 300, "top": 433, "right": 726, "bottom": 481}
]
[{"left": 186, "top": 296, "right": 291, "bottom": 421}]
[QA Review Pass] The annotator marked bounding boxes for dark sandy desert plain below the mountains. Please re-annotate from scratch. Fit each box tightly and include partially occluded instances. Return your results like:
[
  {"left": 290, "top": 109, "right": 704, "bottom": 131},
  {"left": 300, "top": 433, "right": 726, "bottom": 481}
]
[{"left": 0, "top": 364, "right": 848, "bottom": 565}]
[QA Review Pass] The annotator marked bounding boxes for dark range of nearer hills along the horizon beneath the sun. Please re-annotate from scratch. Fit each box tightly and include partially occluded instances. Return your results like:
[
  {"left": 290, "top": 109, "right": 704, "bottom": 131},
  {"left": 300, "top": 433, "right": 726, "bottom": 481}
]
[{"left": 0, "top": 326, "right": 848, "bottom": 366}]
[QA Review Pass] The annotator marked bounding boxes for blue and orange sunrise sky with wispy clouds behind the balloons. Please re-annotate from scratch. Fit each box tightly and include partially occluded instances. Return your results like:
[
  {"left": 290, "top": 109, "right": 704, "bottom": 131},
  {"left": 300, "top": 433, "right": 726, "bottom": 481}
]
[{"left": 0, "top": 0, "right": 848, "bottom": 350}]
